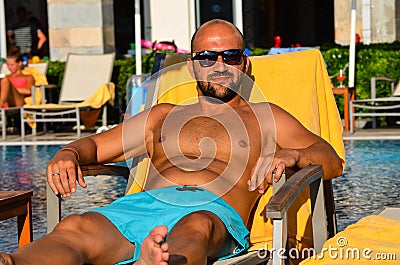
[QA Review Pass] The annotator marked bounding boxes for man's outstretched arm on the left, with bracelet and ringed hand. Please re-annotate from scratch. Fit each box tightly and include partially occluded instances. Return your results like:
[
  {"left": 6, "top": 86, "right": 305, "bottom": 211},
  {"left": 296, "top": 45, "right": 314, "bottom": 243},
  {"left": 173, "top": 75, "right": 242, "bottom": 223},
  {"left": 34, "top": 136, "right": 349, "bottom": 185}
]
[{"left": 47, "top": 106, "right": 156, "bottom": 197}]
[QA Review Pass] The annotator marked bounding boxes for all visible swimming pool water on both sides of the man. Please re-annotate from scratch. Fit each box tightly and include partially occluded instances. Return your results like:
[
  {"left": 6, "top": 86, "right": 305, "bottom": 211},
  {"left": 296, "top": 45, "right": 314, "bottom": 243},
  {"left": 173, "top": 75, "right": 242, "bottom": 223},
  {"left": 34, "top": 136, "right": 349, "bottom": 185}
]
[{"left": 0, "top": 141, "right": 400, "bottom": 252}]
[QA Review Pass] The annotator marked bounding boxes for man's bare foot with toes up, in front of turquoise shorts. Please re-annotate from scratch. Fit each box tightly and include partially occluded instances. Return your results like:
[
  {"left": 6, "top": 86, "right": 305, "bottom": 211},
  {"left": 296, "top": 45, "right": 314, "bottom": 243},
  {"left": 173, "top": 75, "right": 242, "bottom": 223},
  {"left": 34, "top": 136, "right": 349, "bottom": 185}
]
[{"left": 135, "top": 226, "right": 169, "bottom": 265}]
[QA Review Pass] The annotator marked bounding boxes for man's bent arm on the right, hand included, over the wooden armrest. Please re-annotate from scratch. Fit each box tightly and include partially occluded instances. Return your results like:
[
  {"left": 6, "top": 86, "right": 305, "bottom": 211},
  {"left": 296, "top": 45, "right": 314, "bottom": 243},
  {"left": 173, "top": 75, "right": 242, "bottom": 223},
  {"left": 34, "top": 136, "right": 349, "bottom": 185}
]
[{"left": 249, "top": 104, "right": 343, "bottom": 192}]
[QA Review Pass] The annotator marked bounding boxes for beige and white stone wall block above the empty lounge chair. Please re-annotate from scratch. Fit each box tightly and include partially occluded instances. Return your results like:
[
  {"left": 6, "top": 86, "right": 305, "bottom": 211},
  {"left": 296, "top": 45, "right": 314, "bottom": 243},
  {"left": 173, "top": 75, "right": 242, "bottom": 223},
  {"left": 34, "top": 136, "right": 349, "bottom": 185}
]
[{"left": 47, "top": 0, "right": 115, "bottom": 61}]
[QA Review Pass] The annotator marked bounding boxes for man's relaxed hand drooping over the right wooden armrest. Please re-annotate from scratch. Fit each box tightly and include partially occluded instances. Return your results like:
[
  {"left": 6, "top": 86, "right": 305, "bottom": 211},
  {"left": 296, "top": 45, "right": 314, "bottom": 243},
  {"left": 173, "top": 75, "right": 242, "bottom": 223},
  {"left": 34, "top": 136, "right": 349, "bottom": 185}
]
[{"left": 248, "top": 149, "right": 299, "bottom": 193}]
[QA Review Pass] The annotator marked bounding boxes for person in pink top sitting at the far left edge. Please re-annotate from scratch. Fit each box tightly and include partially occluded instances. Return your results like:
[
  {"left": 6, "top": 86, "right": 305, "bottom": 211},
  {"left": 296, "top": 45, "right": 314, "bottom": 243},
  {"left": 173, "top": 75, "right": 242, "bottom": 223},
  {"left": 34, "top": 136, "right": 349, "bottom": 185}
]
[{"left": 0, "top": 46, "right": 35, "bottom": 108}]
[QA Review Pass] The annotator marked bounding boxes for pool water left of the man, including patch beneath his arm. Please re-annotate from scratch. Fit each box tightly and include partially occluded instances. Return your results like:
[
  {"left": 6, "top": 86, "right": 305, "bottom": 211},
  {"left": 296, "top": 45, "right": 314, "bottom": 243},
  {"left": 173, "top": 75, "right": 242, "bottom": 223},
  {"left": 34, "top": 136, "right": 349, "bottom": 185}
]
[{"left": 0, "top": 145, "right": 126, "bottom": 252}]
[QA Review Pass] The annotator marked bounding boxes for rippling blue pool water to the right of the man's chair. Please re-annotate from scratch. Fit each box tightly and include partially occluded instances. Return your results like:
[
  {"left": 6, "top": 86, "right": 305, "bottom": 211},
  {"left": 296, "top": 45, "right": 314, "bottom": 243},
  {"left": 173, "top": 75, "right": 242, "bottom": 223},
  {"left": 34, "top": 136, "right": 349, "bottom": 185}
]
[{"left": 332, "top": 140, "right": 400, "bottom": 231}]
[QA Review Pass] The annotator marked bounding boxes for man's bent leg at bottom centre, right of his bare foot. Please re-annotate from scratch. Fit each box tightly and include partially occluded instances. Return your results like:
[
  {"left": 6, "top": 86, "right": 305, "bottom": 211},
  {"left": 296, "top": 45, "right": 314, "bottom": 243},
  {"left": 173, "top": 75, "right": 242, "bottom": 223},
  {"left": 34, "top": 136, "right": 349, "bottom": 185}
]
[{"left": 166, "top": 211, "right": 235, "bottom": 265}]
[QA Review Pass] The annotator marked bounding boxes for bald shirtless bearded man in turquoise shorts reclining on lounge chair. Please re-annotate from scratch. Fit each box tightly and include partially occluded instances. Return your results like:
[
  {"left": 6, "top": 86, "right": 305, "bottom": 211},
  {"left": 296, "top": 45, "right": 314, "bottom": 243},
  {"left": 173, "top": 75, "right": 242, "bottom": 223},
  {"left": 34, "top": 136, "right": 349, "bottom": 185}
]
[{"left": 3, "top": 20, "right": 342, "bottom": 264}]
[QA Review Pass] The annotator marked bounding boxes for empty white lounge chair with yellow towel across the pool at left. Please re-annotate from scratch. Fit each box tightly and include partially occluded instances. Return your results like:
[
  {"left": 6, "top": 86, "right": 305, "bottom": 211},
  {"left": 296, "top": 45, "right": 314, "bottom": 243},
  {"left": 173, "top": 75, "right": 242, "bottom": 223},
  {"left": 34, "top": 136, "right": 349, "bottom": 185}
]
[{"left": 21, "top": 53, "right": 115, "bottom": 138}]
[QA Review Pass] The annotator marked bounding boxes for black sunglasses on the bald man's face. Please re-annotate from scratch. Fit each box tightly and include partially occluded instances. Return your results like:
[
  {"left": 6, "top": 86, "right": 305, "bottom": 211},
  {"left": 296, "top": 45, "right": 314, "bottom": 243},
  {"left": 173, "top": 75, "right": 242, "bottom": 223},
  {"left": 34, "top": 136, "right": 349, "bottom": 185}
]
[{"left": 192, "top": 49, "right": 244, "bottom": 67}]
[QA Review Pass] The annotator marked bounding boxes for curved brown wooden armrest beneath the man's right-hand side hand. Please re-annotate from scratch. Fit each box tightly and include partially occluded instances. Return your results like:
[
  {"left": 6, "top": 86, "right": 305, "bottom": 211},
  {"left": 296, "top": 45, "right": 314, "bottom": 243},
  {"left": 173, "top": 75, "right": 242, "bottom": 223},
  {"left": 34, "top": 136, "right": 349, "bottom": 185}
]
[{"left": 266, "top": 165, "right": 322, "bottom": 218}]
